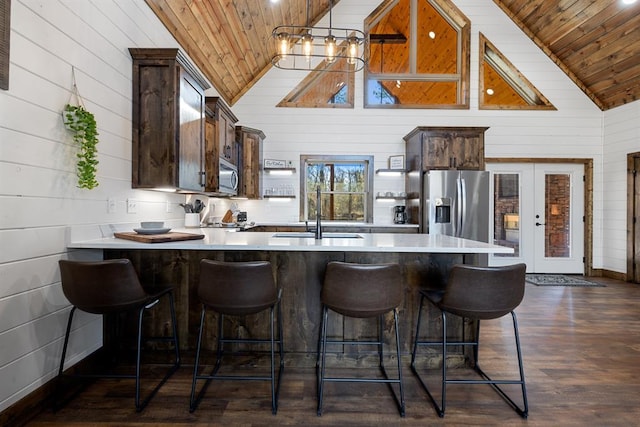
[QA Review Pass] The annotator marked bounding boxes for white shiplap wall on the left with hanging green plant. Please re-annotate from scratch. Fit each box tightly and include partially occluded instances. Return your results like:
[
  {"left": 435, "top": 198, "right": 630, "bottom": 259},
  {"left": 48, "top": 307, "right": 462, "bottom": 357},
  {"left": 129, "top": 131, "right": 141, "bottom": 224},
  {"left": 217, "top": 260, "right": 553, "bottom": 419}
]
[{"left": 0, "top": 0, "right": 191, "bottom": 410}]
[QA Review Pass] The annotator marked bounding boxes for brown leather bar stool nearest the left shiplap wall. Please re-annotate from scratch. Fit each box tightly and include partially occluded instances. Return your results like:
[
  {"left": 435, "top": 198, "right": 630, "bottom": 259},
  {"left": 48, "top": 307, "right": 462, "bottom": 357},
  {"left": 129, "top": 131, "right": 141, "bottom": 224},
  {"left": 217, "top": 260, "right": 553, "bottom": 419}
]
[{"left": 54, "top": 259, "right": 180, "bottom": 412}]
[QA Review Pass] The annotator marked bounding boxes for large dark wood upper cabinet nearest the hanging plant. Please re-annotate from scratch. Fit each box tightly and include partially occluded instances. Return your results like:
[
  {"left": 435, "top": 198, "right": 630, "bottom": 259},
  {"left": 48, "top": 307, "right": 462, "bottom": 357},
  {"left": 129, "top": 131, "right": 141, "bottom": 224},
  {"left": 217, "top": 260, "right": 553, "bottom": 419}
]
[{"left": 129, "top": 48, "right": 209, "bottom": 192}]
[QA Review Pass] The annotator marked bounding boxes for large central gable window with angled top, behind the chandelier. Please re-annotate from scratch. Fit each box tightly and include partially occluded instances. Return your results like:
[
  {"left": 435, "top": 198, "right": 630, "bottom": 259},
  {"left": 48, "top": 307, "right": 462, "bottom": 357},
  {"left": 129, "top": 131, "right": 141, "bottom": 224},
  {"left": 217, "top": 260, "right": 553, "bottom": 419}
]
[{"left": 364, "top": 0, "right": 471, "bottom": 108}]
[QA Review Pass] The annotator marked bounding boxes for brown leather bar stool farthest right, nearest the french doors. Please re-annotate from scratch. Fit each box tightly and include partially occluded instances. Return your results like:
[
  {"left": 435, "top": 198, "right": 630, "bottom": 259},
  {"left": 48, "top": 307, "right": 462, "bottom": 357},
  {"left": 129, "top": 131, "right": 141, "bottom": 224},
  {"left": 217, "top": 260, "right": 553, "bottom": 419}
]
[{"left": 411, "top": 264, "right": 529, "bottom": 418}]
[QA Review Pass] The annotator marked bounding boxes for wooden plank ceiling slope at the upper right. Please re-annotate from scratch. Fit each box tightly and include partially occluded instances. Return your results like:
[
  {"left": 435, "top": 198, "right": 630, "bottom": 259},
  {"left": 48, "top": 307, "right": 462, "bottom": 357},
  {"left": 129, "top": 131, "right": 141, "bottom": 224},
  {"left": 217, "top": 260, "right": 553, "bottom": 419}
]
[{"left": 494, "top": 0, "right": 640, "bottom": 110}]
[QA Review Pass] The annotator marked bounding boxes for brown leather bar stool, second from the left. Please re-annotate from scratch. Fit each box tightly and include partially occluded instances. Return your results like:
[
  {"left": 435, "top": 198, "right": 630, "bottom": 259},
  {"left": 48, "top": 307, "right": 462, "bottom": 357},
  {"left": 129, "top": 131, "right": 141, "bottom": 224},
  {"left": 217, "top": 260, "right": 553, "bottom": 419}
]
[{"left": 189, "top": 259, "right": 284, "bottom": 415}]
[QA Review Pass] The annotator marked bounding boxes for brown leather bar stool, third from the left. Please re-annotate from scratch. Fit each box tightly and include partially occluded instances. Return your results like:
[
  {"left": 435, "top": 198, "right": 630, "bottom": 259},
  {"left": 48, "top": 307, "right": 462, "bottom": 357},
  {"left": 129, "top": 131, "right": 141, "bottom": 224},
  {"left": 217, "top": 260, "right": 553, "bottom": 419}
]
[{"left": 316, "top": 261, "right": 405, "bottom": 417}]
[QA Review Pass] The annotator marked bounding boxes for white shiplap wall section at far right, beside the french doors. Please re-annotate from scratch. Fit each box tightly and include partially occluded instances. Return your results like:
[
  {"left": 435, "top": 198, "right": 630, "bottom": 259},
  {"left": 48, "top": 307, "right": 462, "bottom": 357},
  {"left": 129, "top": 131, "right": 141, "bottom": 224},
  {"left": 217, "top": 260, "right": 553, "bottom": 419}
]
[{"left": 596, "top": 101, "right": 640, "bottom": 273}]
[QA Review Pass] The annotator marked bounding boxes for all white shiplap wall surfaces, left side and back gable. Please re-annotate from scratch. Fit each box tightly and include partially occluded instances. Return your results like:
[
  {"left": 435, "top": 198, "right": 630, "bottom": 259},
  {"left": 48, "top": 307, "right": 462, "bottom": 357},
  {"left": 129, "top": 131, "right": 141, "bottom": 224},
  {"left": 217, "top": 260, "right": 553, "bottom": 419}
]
[{"left": 0, "top": 0, "right": 640, "bottom": 411}]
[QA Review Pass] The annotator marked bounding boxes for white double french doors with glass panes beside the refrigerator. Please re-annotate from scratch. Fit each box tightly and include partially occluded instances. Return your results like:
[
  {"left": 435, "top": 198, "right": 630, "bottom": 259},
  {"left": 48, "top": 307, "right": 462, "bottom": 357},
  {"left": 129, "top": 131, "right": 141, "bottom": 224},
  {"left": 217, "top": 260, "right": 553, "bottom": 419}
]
[{"left": 487, "top": 163, "right": 584, "bottom": 274}]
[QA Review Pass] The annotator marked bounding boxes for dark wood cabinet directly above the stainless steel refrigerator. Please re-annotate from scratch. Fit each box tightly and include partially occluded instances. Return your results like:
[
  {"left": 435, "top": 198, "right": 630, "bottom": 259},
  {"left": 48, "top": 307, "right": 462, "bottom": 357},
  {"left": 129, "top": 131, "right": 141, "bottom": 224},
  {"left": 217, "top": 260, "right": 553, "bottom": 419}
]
[{"left": 404, "top": 126, "right": 488, "bottom": 172}]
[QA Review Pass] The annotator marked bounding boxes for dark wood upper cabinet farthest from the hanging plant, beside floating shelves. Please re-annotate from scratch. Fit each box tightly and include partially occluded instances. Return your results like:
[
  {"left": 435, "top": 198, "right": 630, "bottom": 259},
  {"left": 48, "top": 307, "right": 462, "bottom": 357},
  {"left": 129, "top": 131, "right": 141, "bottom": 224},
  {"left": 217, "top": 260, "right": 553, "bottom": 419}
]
[{"left": 236, "top": 126, "right": 265, "bottom": 199}]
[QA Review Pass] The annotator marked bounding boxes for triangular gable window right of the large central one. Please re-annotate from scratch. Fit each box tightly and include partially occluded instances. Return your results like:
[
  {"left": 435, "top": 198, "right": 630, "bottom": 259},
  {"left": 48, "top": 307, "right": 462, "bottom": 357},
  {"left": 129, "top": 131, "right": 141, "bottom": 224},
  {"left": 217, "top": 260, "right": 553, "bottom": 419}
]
[{"left": 478, "top": 33, "right": 556, "bottom": 110}]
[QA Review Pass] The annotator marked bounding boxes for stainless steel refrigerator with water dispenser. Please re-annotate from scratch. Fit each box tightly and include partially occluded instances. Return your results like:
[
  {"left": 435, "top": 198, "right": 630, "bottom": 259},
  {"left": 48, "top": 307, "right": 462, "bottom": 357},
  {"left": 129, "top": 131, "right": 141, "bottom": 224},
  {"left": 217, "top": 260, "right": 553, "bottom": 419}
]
[{"left": 421, "top": 170, "right": 491, "bottom": 242}]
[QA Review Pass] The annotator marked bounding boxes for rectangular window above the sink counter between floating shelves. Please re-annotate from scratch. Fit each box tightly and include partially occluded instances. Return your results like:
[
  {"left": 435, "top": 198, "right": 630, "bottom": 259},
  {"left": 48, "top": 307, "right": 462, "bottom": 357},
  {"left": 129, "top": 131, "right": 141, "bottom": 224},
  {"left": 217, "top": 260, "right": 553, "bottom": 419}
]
[{"left": 300, "top": 155, "right": 373, "bottom": 222}]
